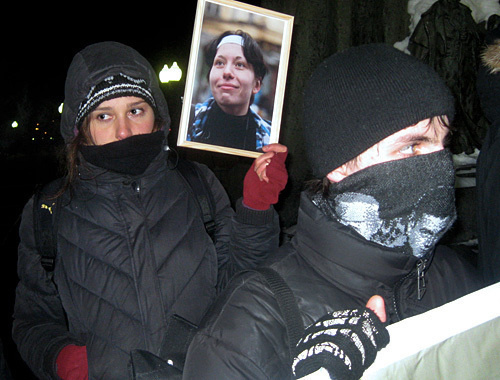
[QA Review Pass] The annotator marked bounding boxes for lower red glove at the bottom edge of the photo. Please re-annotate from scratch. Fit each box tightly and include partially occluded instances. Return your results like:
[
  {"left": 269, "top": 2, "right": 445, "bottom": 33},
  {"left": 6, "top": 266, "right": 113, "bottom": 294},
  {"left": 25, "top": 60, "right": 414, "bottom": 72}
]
[{"left": 56, "top": 344, "right": 89, "bottom": 380}]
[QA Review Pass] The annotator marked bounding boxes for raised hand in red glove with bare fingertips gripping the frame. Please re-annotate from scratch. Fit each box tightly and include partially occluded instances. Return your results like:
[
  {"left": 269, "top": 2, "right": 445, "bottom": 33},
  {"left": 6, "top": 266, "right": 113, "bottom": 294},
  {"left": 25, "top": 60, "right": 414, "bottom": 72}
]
[{"left": 243, "top": 144, "right": 288, "bottom": 210}]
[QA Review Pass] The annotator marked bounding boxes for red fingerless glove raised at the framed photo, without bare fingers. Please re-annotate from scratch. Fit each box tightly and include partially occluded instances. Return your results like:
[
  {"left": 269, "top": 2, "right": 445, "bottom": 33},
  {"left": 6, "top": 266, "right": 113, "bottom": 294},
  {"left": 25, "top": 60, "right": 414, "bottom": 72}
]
[{"left": 243, "top": 152, "right": 288, "bottom": 210}]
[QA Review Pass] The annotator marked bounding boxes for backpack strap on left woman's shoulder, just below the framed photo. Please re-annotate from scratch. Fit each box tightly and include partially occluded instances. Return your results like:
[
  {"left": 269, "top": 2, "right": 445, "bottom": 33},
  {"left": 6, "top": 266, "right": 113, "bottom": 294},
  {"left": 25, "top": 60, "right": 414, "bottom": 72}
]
[{"left": 176, "top": 158, "right": 216, "bottom": 242}]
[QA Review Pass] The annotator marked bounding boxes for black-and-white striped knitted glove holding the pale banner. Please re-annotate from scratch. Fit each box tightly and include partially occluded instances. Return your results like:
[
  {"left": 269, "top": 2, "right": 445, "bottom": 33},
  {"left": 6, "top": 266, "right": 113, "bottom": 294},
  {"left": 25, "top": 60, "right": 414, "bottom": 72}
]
[{"left": 292, "top": 308, "right": 389, "bottom": 380}]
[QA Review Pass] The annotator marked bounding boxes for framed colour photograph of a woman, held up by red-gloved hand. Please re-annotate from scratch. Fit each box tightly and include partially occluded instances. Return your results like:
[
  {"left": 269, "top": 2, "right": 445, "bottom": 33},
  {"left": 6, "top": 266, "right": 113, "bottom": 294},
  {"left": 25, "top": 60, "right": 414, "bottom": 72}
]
[{"left": 177, "top": 0, "right": 293, "bottom": 157}]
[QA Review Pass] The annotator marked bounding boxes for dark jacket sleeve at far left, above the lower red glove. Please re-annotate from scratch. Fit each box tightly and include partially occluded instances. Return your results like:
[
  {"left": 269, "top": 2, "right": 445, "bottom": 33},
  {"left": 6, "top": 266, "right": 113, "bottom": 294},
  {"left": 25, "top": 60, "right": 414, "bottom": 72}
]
[{"left": 12, "top": 199, "right": 77, "bottom": 379}]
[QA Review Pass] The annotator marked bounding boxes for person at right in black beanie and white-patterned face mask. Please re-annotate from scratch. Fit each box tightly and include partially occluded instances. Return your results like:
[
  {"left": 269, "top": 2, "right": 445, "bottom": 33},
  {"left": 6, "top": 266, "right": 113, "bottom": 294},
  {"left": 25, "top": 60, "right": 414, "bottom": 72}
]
[{"left": 184, "top": 44, "right": 482, "bottom": 380}]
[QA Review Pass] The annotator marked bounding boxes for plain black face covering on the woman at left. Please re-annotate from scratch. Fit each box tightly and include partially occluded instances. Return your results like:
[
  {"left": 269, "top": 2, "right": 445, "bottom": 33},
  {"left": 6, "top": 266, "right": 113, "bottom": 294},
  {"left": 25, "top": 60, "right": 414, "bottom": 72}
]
[{"left": 80, "top": 131, "right": 165, "bottom": 175}]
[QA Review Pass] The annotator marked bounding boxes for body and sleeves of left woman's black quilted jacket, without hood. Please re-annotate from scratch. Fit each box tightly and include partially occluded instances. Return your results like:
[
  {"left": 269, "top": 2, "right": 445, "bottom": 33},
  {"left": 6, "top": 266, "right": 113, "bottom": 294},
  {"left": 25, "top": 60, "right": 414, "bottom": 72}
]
[{"left": 13, "top": 41, "right": 279, "bottom": 380}]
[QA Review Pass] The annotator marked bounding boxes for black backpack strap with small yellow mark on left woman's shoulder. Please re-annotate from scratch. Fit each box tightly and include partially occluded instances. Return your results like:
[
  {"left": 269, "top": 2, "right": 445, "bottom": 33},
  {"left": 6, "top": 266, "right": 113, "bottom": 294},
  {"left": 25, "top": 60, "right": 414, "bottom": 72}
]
[{"left": 33, "top": 178, "right": 63, "bottom": 272}]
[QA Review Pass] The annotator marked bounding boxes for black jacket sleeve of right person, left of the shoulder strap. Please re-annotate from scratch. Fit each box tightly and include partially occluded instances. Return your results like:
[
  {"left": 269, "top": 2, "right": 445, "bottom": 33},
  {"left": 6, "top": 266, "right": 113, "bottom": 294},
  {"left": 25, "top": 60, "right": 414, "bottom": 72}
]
[{"left": 182, "top": 273, "right": 292, "bottom": 380}]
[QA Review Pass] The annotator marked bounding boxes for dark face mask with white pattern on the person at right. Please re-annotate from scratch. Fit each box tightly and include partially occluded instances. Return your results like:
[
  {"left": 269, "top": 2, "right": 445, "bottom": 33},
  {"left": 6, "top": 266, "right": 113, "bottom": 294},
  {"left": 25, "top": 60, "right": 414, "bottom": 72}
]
[{"left": 312, "top": 150, "right": 456, "bottom": 257}]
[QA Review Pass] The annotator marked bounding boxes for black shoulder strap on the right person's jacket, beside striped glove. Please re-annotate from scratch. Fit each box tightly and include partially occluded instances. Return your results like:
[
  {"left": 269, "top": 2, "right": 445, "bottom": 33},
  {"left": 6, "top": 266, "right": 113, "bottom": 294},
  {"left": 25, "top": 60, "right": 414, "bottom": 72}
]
[{"left": 254, "top": 267, "right": 305, "bottom": 368}]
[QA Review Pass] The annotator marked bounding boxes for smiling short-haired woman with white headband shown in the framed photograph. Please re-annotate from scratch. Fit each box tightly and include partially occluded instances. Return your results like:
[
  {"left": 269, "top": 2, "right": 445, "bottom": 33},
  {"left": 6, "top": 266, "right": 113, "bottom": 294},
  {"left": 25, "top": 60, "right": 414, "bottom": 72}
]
[{"left": 188, "top": 30, "right": 271, "bottom": 151}]
